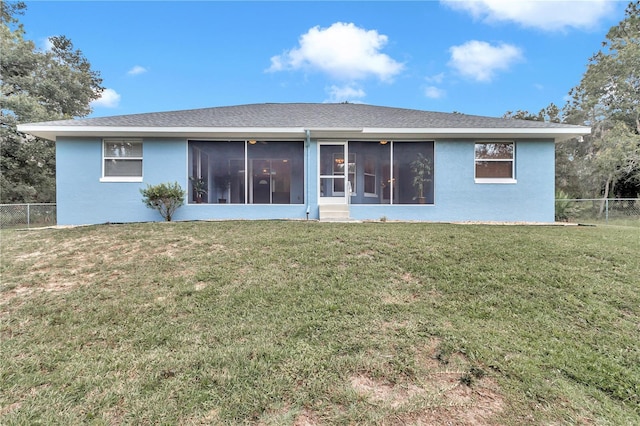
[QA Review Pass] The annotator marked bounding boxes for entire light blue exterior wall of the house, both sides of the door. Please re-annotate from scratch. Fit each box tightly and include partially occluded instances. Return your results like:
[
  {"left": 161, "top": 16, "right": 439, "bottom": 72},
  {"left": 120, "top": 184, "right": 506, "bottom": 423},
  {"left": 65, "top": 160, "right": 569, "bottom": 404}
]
[{"left": 56, "top": 138, "right": 555, "bottom": 225}]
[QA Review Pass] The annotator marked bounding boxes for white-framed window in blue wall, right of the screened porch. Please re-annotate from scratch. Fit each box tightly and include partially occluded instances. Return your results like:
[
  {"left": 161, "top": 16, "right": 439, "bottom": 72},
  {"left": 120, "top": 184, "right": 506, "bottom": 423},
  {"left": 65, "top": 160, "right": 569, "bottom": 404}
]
[{"left": 475, "top": 142, "right": 515, "bottom": 183}]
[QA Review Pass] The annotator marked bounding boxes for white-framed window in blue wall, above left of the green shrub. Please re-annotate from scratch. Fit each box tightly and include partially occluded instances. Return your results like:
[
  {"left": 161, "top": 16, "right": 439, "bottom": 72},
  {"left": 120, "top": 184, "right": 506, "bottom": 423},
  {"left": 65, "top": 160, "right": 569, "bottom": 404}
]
[{"left": 101, "top": 139, "right": 142, "bottom": 182}]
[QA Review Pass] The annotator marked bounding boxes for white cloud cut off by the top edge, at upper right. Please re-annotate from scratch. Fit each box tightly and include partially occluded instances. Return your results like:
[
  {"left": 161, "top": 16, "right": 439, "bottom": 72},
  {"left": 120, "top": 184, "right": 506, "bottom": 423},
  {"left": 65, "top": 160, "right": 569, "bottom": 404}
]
[{"left": 441, "top": 0, "right": 615, "bottom": 31}]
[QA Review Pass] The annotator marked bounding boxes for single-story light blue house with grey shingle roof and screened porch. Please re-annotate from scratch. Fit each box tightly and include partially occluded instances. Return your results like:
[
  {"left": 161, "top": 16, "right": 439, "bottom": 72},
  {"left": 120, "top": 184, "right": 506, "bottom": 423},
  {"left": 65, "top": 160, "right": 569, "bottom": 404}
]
[{"left": 18, "top": 103, "right": 590, "bottom": 225}]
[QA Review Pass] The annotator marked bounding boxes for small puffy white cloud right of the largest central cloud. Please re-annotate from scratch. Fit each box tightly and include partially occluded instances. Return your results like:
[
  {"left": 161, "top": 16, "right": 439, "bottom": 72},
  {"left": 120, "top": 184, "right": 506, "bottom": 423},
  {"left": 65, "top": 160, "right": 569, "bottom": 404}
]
[{"left": 449, "top": 40, "right": 523, "bottom": 82}]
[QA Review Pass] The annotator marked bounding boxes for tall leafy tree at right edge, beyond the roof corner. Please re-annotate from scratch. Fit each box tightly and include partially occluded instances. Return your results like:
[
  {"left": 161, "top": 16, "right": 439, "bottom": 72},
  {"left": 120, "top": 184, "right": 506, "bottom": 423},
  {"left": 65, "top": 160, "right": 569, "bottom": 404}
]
[{"left": 564, "top": 1, "right": 640, "bottom": 197}]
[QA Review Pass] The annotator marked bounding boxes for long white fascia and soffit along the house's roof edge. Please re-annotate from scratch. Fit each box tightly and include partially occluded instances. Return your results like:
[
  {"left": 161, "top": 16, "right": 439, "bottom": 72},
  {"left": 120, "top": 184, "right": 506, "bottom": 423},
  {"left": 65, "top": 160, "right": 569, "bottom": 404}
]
[{"left": 18, "top": 124, "right": 591, "bottom": 141}]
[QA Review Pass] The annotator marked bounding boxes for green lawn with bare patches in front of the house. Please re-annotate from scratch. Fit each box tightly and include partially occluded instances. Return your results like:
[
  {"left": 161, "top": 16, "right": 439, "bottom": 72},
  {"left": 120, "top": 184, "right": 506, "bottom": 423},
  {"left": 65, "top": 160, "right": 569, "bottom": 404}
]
[{"left": 0, "top": 221, "right": 640, "bottom": 426}]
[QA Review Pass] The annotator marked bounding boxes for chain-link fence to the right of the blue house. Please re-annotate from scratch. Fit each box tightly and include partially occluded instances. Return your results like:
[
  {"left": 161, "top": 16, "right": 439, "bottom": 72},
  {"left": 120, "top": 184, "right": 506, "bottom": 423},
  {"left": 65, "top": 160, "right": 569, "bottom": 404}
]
[{"left": 556, "top": 198, "right": 640, "bottom": 226}]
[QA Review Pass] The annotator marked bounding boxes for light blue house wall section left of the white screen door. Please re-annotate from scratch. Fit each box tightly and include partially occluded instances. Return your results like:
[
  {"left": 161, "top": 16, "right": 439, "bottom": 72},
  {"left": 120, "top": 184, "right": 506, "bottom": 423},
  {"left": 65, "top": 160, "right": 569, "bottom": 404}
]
[{"left": 56, "top": 138, "right": 317, "bottom": 225}]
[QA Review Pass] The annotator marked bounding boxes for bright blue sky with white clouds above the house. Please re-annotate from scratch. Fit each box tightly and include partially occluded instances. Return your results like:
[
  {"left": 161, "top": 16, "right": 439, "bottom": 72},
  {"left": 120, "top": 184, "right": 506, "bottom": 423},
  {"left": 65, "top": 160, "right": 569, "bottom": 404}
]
[{"left": 19, "top": 0, "right": 627, "bottom": 117}]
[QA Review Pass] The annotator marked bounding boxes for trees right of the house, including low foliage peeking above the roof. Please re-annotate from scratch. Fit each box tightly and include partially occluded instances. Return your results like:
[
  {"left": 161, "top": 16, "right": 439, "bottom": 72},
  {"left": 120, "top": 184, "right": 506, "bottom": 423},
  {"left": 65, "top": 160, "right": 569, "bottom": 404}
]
[{"left": 504, "top": 1, "right": 640, "bottom": 198}]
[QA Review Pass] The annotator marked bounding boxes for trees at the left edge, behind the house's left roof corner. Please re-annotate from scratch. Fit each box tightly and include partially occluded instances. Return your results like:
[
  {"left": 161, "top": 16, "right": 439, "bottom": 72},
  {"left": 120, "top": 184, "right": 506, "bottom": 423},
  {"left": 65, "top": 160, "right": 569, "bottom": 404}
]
[{"left": 0, "top": 1, "right": 104, "bottom": 203}]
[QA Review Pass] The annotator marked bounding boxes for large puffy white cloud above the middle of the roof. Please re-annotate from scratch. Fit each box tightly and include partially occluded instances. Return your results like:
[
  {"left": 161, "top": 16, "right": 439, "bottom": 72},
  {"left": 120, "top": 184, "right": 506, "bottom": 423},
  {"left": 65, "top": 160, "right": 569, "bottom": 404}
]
[{"left": 267, "top": 22, "right": 404, "bottom": 81}]
